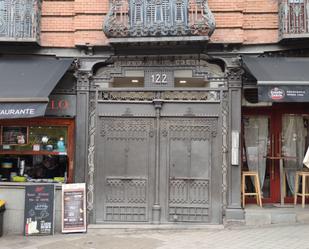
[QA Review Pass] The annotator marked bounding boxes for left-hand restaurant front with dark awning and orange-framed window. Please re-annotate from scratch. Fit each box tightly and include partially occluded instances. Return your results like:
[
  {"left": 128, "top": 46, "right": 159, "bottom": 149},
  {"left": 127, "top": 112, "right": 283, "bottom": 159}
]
[{"left": 0, "top": 56, "right": 76, "bottom": 233}]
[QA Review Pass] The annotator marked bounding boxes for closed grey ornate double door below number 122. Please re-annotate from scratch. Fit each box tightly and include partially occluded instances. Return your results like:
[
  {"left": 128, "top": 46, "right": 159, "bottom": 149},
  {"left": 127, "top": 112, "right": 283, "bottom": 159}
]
[{"left": 95, "top": 103, "right": 220, "bottom": 223}]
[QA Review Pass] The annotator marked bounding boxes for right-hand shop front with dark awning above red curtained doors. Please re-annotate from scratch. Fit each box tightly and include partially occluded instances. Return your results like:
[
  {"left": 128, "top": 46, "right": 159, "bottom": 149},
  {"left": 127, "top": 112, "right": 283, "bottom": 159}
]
[{"left": 242, "top": 57, "right": 309, "bottom": 206}]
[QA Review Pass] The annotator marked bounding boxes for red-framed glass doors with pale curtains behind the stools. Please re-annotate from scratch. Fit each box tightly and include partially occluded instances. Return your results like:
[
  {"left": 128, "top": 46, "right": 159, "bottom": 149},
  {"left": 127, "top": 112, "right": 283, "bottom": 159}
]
[{"left": 242, "top": 104, "right": 309, "bottom": 203}]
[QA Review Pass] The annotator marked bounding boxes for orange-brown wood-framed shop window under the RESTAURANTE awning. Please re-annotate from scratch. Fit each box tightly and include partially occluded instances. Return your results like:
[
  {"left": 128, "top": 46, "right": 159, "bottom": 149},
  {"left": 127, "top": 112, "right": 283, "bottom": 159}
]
[{"left": 0, "top": 119, "right": 73, "bottom": 182}]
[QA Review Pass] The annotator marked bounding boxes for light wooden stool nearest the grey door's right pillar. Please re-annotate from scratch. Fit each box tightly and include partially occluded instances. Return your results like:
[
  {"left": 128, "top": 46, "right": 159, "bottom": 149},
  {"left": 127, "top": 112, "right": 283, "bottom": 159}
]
[{"left": 241, "top": 171, "right": 262, "bottom": 207}]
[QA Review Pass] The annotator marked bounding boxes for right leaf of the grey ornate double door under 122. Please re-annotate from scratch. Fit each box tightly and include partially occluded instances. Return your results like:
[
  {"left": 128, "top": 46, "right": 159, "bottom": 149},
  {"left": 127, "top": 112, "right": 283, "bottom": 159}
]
[{"left": 161, "top": 118, "right": 217, "bottom": 222}]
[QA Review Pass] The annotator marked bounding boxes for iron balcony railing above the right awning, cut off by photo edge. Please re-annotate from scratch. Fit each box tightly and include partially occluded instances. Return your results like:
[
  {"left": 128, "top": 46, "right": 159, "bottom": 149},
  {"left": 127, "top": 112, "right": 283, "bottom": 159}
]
[{"left": 279, "top": 0, "right": 309, "bottom": 40}]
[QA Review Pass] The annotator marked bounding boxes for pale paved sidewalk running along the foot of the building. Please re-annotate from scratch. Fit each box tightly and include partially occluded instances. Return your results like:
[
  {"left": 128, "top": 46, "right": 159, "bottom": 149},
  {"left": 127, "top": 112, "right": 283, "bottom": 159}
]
[{"left": 0, "top": 225, "right": 309, "bottom": 249}]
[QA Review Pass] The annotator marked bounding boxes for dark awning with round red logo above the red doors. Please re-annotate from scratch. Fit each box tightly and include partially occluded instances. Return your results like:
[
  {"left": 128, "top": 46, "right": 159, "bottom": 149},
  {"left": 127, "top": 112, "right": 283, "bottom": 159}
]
[{"left": 242, "top": 56, "right": 309, "bottom": 102}]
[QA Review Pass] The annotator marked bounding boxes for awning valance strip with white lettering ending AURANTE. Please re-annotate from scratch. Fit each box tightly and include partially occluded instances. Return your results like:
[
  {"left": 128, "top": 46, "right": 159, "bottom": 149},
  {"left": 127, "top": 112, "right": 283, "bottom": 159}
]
[{"left": 0, "top": 103, "right": 47, "bottom": 119}]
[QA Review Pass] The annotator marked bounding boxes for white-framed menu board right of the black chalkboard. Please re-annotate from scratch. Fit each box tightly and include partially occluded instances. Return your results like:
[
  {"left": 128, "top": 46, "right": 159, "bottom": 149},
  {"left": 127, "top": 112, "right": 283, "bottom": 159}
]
[{"left": 62, "top": 183, "right": 87, "bottom": 233}]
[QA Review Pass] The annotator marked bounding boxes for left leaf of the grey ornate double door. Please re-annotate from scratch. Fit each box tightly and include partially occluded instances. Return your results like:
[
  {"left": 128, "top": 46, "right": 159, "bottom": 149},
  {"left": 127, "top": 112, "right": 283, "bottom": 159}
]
[{"left": 95, "top": 117, "right": 154, "bottom": 222}]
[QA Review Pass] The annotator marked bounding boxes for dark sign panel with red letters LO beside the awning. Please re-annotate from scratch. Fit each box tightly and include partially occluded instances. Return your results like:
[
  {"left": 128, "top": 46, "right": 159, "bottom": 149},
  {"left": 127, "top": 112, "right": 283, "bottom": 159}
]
[{"left": 45, "top": 95, "right": 76, "bottom": 117}]
